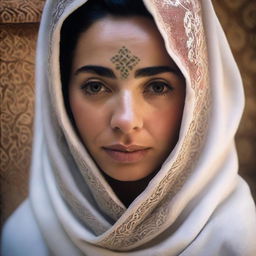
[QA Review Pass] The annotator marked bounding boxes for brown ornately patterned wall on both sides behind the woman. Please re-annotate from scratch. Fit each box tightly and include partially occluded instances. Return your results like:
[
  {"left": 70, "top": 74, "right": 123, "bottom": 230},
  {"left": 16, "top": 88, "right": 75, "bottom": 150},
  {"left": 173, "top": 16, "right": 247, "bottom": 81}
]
[{"left": 0, "top": 0, "right": 256, "bottom": 228}]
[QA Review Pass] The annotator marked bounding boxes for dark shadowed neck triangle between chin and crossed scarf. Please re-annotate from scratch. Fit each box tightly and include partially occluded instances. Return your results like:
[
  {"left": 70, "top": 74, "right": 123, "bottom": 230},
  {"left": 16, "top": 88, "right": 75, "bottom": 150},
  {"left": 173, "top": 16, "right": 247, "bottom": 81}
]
[{"left": 103, "top": 172, "right": 156, "bottom": 207}]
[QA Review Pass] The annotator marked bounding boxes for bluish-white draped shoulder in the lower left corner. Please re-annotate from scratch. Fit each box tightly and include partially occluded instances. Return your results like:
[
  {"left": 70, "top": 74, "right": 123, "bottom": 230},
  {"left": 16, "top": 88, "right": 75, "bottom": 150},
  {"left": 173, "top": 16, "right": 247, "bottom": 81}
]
[{"left": 1, "top": 200, "right": 49, "bottom": 256}]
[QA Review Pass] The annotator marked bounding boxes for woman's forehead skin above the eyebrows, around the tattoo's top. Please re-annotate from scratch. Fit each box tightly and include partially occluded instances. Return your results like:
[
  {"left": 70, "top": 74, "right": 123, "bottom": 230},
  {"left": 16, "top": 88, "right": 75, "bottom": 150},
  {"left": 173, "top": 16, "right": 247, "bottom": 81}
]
[{"left": 73, "top": 17, "right": 175, "bottom": 66}]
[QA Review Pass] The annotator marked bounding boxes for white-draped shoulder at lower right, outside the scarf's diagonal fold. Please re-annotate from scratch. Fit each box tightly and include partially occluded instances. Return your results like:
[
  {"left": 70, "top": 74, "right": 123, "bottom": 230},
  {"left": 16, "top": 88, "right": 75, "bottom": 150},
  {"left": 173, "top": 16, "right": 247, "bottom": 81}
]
[{"left": 181, "top": 178, "right": 256, "bottom": 256}]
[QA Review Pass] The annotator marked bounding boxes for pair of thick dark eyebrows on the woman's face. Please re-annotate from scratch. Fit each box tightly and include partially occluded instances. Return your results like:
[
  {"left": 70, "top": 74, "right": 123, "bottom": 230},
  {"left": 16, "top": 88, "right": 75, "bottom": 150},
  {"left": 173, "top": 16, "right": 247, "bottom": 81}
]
[{"left": 75, "top": 65, "right": 181, "bottom": 78}]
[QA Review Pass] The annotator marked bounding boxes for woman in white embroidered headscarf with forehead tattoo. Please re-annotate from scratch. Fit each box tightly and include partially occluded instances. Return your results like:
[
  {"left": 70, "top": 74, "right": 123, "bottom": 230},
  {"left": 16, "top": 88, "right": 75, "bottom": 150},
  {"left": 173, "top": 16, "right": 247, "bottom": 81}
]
[{"left": 3, "top": 0, "right": 256, "bottom": 256}]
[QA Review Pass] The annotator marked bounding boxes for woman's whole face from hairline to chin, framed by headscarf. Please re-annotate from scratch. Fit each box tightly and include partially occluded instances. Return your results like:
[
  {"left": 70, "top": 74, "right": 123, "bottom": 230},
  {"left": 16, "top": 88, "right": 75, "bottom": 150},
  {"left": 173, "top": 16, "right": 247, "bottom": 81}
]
[{"left": 69, "top": 17, "right": 185, "bottom": 181}]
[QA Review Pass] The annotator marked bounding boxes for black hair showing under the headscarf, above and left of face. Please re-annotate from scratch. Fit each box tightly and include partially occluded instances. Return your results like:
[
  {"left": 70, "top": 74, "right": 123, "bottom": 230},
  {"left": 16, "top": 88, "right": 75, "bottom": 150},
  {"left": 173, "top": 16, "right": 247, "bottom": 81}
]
[{"left": 60, "top": 0, "right": 152, "bottom": 118}]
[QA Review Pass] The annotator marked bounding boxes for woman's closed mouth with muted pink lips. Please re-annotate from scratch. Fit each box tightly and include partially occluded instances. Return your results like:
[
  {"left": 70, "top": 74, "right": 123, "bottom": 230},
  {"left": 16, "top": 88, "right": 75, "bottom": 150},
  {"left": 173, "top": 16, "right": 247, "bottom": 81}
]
[{"left": 102, "top": 144, "right": 151, "bottom": 163}]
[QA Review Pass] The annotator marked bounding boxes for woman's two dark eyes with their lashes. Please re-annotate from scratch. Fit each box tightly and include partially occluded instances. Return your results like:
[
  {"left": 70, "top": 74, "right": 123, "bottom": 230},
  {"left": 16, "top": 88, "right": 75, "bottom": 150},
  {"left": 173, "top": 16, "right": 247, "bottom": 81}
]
[{"left": 80, "top": 80, "right": 174, "bottom": 96}]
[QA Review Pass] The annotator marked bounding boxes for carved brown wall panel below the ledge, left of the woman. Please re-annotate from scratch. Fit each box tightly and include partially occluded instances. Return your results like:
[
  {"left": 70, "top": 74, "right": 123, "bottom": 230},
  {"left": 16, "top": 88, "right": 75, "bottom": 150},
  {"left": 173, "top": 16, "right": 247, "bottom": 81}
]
[{"left": 0, "top": 24, "right": 38, "bottom": 228}]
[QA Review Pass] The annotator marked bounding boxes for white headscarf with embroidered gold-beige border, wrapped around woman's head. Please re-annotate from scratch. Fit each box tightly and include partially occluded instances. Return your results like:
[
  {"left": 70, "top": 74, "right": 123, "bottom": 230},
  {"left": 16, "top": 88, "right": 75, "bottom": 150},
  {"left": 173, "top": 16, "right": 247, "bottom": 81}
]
[{"left": 4, "top": 0, "right": 256, "bottom": 256}]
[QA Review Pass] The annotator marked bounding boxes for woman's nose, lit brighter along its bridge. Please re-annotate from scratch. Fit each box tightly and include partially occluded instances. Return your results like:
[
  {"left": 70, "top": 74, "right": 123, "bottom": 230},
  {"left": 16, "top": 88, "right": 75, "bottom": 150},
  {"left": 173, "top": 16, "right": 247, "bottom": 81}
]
[{"left": 110, "top": 91, "right": 143, "bottom": 134}]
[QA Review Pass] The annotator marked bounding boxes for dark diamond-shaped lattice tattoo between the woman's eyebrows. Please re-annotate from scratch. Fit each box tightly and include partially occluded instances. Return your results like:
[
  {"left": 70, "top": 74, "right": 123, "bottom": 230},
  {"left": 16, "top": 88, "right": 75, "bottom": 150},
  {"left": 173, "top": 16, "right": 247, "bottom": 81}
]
[{"left": 111, "top": 46, "right": 140, "bottom": 79}]
